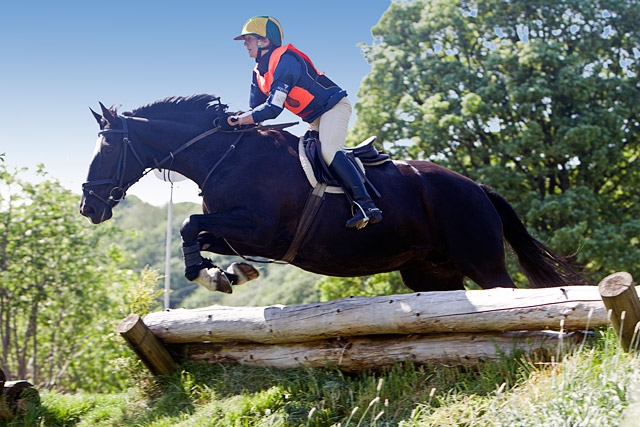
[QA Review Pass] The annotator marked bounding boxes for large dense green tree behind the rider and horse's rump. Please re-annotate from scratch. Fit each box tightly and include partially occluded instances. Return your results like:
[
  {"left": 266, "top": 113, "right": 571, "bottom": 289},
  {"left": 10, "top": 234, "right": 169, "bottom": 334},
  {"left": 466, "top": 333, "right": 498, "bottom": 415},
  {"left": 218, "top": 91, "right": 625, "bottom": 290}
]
[{"left": 352, "top": 0, "right": 640, "bottom": 280}]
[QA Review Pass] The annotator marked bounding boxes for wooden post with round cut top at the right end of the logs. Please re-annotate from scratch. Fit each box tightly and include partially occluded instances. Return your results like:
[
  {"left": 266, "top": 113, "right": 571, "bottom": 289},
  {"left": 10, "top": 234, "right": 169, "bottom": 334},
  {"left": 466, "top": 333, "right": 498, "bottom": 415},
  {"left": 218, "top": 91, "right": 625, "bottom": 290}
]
[{"left": 598, "top": 272, "right": 640, "bottom": 351}]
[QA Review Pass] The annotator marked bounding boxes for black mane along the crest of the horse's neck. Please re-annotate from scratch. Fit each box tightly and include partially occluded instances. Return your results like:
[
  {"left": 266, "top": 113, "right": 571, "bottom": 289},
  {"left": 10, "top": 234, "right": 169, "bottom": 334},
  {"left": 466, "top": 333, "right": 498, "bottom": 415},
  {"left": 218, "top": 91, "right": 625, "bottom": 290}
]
[{"left": 124, "top": 94, "right": 228, "bottom": 118}]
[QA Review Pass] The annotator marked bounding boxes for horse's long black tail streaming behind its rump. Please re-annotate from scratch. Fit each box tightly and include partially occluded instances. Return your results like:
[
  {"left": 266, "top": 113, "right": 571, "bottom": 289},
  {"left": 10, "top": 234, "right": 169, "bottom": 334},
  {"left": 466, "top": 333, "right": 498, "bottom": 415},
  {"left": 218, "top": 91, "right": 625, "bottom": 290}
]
[{"left": 480, "top": 184, "right": 585, "bottom": 288}]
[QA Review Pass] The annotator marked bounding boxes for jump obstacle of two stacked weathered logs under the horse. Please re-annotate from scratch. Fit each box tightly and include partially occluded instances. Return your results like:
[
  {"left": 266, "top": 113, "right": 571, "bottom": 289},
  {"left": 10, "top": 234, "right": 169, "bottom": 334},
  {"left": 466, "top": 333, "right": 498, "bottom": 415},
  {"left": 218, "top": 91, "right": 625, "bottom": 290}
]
[{"left": 118, "top": 286, "right": 608, "bottom": 372}]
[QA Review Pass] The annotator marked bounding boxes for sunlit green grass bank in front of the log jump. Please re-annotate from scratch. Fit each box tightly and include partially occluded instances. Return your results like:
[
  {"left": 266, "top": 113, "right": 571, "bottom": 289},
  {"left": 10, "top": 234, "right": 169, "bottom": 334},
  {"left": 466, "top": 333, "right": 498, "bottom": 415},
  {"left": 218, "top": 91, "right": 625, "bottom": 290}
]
[{"left": 0, "top": 330, "right": 640, "bottom": 427}]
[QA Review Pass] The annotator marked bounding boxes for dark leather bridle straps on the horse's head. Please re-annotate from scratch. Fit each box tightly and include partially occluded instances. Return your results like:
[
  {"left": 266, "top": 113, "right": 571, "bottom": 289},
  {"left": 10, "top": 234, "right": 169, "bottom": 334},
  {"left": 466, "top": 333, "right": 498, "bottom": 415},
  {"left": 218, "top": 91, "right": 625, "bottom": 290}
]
[{"left": 82, "top": 116, "right": 144, "bottom": 208}]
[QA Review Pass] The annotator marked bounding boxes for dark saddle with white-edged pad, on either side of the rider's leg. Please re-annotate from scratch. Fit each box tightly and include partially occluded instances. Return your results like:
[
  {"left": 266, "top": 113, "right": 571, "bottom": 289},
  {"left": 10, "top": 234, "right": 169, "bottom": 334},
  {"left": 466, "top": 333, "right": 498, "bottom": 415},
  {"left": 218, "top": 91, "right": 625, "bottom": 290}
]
[{"left": 300, "top": 131, "right": 391, "bottom": 192}]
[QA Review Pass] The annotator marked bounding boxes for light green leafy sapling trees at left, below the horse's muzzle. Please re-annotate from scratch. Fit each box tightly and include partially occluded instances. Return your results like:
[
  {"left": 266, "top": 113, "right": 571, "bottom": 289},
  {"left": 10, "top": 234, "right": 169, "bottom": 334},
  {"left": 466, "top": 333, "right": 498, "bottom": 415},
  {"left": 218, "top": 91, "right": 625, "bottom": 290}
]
[{"left": 0, "top": 163, "right": 158, "bottom": 390}]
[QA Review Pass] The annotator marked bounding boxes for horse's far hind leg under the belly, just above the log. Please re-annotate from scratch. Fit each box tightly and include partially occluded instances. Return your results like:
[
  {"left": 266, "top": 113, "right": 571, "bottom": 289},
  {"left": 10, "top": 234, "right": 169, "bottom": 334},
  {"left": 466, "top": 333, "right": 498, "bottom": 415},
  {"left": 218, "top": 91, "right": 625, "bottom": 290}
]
[{"left": 400, "top": 265, "right": 464, "bottom": 292}]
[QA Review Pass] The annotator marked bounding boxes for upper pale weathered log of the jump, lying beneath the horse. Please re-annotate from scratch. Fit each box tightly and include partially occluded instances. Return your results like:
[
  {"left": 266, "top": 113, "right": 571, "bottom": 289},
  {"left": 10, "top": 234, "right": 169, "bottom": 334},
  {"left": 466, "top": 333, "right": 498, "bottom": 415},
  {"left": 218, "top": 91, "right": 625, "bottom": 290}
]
[{"left": 144, "top": 286, "right": 607, "bottom": 344}]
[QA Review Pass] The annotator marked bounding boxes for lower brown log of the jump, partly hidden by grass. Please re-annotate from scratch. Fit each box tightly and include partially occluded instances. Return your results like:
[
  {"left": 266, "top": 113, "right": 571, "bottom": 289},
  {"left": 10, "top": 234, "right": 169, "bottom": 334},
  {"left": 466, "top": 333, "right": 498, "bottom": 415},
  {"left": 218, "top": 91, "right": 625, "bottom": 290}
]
[{"left": 188, "top": 332, "right": 581, "bottom": 372}]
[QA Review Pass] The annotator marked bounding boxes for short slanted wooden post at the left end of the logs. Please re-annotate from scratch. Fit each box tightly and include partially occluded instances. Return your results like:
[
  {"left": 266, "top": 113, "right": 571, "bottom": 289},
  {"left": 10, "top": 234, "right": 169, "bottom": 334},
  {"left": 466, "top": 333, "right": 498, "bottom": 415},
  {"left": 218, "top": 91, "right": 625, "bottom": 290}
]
[{"left": 117, "top": 314, "right": 176, "bottom": 375}]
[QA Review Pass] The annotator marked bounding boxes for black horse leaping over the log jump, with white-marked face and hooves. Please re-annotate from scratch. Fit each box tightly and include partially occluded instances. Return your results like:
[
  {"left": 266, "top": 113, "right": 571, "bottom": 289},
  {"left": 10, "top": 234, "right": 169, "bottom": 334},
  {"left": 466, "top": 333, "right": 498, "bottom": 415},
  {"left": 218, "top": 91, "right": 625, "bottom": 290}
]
[{"left": 80, "top": 95, "right": 580, "bottom": 292}]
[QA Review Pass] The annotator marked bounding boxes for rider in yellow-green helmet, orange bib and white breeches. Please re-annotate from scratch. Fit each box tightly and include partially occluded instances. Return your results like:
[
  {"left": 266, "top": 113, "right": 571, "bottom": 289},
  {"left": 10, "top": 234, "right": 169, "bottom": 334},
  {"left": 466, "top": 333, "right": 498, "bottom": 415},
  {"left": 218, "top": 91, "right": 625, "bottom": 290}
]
[{"left": 227, "top": 16, "right": 382, "bottom": 229}]
